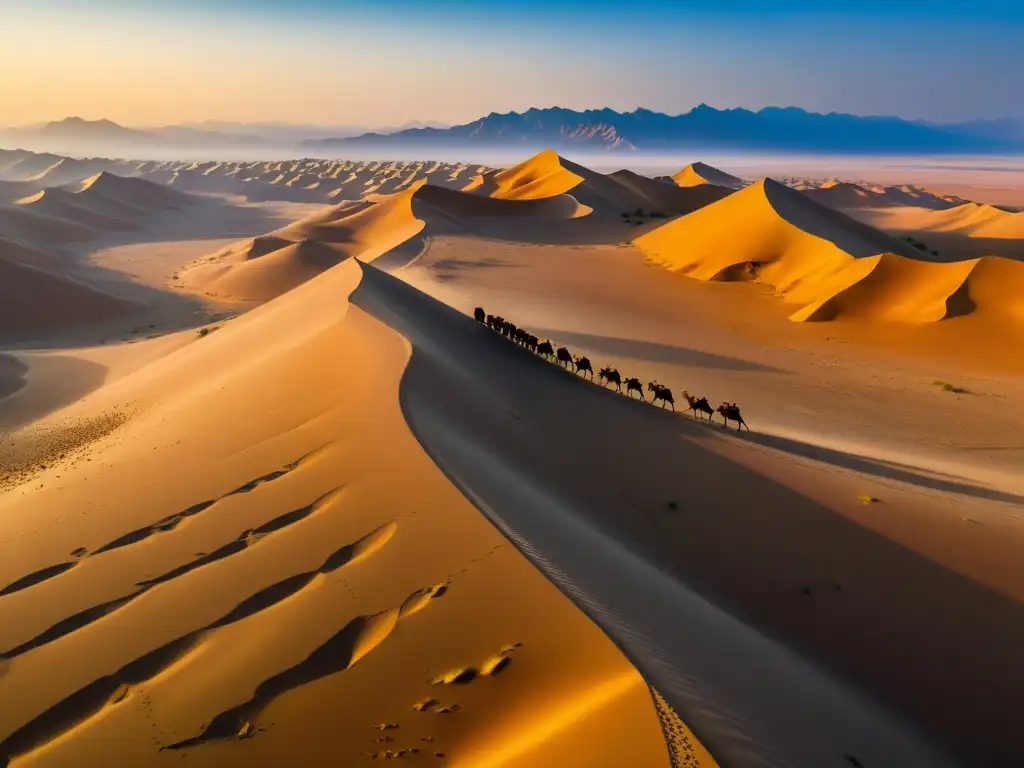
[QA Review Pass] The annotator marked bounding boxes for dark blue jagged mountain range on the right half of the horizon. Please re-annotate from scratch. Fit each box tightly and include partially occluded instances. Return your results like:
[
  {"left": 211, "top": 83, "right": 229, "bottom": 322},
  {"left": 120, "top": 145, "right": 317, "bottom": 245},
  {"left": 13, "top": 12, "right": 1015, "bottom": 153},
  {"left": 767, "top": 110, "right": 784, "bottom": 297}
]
[{"left": 303, "top": 104, "right": 1024, "bottom": 154}]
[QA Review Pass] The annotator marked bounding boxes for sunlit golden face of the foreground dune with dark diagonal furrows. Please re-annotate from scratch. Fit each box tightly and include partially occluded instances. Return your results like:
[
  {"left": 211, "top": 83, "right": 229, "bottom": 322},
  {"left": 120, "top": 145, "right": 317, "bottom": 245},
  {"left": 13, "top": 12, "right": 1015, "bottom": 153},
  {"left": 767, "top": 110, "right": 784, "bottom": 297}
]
[{"left": 0, "top": 256, "right": 688, "bottom": 768}]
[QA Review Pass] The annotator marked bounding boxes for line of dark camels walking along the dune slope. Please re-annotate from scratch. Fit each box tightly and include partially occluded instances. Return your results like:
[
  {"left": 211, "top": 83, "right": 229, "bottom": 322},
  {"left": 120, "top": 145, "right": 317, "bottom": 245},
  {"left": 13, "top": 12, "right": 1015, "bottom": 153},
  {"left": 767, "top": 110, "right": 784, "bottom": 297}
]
[{"left": 473, "top": 307, "right": 751, "bottom": 432}]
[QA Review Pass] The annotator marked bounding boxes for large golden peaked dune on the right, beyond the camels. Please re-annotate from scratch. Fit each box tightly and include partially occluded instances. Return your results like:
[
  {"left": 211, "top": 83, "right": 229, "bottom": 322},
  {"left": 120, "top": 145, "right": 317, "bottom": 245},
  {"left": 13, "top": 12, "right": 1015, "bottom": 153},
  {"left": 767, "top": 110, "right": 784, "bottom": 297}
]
[{"left": 636, "top": 179, "right": 1024, "bottom": 334}]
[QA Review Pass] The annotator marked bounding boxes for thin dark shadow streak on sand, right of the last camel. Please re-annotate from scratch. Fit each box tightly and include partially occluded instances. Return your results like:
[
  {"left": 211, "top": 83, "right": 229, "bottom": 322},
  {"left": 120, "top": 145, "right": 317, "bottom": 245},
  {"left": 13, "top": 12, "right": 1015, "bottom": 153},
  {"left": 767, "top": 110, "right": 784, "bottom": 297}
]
[{"left": 737, "top": 432, "right": 1024, "bottom": 504}]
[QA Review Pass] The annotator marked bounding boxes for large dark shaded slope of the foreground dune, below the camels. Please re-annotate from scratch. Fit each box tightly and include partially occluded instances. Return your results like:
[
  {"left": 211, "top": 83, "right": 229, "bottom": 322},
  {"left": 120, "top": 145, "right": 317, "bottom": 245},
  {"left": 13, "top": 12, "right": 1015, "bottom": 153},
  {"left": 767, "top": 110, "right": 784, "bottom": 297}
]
[{"left": 351, "top": 266, "right": 1024, "bottom": 768}]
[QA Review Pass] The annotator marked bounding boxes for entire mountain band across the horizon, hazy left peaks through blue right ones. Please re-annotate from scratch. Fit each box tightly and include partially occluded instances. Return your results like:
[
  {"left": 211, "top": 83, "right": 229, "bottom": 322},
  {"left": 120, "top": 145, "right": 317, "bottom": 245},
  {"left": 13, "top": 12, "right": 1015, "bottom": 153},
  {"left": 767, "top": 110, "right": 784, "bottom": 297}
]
[{"left": 0, "top": 104, "right": 1024, "bottom": 155}]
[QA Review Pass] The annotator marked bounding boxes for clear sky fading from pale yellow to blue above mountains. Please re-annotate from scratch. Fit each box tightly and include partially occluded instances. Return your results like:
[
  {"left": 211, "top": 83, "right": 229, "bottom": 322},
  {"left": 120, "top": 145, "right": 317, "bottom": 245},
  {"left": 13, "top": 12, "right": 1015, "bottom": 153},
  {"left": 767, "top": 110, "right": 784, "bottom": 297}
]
[{"left": 0, "top": 0, "right": 1024, "bottom": 126}]
